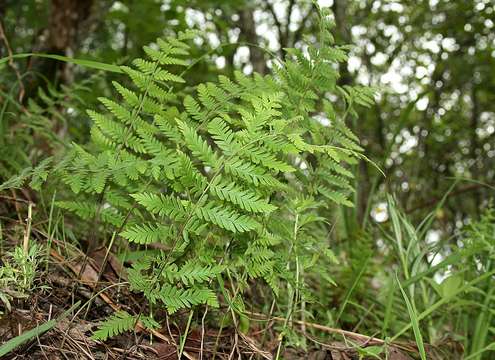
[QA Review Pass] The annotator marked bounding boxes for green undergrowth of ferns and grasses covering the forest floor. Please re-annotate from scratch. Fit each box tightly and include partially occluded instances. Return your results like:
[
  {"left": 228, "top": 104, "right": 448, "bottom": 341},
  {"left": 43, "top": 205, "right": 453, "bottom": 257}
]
[{"left": 0, "top": 6, "right": 495, "bottom": 359}]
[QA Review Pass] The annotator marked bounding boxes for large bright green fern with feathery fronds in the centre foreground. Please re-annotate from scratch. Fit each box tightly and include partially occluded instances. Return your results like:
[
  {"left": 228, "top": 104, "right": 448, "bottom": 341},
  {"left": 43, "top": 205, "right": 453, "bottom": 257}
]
[{"left": 58, "top": 10, "right": 372, "bottom": 334}]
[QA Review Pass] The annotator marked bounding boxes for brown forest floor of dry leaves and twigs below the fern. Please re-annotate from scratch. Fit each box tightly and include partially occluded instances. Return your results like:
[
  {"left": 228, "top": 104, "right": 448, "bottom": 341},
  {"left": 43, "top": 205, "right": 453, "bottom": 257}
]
[{"left": 0, "top": 230, "right": 456, "bottom": 360}]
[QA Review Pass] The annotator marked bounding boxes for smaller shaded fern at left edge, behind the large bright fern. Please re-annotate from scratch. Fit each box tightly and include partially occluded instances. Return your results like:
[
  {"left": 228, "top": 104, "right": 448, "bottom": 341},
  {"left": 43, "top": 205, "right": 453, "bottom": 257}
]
[{"left": 0, "top": 79, "right": 92, "bottom": 181}]
